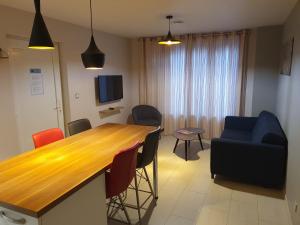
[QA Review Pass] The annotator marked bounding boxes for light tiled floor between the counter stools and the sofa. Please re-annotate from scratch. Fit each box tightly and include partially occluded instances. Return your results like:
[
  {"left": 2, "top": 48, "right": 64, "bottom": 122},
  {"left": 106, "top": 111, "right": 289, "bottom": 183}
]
[{"left": 110, "top": 136, "right": 291, "bottom": 225}]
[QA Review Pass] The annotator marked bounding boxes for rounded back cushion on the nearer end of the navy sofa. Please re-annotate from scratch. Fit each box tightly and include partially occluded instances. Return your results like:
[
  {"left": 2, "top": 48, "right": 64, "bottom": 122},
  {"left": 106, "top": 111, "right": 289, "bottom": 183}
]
[{"left": 252, "top": 111, "right": 286, "bottom": 145}]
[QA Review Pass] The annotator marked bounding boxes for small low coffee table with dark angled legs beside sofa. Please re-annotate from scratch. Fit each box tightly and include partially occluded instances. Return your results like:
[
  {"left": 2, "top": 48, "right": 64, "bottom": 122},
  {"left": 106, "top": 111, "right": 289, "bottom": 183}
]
[{"left": 173, "top": 127, "right": 205, "bottom": 161}]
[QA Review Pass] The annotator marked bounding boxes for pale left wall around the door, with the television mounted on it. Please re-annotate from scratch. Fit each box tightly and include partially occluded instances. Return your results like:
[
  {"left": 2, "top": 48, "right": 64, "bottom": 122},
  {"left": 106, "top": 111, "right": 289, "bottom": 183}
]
[{"left": 0, "top": 6, "right": 134, "bottom": 160}]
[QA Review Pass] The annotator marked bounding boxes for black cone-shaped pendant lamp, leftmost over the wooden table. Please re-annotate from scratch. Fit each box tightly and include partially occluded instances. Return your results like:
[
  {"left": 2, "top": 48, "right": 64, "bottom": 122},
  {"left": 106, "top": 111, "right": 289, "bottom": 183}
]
[{"left": 28, "top": 0, "right": 54, "bottom": 50}]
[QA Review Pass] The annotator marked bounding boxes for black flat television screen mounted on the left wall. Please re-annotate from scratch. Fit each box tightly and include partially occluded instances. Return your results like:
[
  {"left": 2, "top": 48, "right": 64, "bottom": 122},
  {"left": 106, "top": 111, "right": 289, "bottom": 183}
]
[{"left": 98, "top": 75, "right": 123, "bottom": 103}]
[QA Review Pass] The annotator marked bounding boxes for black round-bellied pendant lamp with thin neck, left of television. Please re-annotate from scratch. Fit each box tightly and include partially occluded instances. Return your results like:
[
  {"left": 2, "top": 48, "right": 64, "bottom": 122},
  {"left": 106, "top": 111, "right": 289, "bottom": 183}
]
[{"left": 81, "top": 0, "right": 105, "bottom": 69}]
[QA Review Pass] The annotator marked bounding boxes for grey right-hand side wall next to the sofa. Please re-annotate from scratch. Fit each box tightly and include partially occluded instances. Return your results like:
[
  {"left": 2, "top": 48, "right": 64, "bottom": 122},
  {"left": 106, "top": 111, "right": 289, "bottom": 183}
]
[{"left": 276, "top": 2, "right": 300, "bottom": 225}]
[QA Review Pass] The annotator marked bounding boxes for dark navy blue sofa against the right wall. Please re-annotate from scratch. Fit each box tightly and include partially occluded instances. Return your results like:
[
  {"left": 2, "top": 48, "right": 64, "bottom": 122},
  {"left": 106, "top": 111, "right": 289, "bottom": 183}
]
[{"left": 210, "top": 111, "right": 287, "bottom": 188}]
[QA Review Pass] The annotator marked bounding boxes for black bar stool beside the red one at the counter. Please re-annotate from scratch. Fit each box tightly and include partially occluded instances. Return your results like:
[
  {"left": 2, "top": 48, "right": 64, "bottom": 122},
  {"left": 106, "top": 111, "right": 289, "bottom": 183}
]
[{"left": 131, "top": 127, "right": 160, "bottom": 222}]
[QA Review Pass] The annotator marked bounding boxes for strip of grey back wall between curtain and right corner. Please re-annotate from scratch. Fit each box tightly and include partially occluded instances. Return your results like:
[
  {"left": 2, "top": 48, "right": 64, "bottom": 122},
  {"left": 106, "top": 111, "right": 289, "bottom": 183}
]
[{"left": 245, "top": 26, "right": 282, "bottom": 116}]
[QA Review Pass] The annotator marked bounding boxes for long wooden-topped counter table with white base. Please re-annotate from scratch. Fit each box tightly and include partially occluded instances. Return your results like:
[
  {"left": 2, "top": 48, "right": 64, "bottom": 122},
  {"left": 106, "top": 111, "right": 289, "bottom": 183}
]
[{"left": 0, "top": 124, "right": 155, "bottom": 225}]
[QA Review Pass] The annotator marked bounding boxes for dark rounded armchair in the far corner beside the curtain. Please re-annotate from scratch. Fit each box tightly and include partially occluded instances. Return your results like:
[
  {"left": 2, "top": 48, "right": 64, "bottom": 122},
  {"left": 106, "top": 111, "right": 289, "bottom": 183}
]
[{"left": 132, "top": 105, "right": 162, "bottom": 127}]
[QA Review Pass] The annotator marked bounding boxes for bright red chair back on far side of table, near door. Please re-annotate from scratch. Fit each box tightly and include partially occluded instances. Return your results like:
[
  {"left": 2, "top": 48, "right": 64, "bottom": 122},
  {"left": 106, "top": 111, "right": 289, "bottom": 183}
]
[{"left": 32, "top": 128, "right": 64, "bottom": 148}]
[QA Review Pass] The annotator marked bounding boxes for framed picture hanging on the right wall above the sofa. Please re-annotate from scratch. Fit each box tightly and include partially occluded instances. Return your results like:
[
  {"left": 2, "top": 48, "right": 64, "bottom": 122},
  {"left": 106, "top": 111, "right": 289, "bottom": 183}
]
[{"left": 280, "top": 38, "right": 294, "bottom": 75}]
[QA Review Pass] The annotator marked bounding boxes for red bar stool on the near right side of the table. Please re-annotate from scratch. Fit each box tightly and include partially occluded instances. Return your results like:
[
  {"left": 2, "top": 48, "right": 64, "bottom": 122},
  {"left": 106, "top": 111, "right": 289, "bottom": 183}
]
[{"left": 105, "top": 143, "right": 141, "bottom": 224}]
